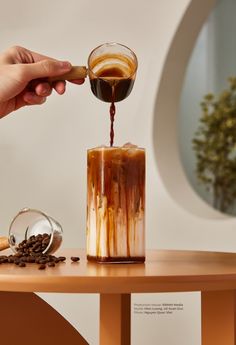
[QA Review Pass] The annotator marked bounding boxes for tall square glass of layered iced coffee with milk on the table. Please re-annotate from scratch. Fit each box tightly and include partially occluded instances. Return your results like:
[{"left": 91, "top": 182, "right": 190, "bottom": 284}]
[{"left": 87, "top": 144, "right": 145, "bottom": 262}]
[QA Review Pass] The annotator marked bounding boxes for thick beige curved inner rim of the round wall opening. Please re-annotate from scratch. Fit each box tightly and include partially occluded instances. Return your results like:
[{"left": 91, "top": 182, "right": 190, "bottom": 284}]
[{"left": 153, "top": 0, "right": 229, "bottom": 219}]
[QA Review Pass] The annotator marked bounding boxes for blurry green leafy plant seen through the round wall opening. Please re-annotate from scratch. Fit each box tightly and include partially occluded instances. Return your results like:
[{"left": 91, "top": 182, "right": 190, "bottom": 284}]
[{"left": 192, "top": 77, "right": 236, "bottom": 212}]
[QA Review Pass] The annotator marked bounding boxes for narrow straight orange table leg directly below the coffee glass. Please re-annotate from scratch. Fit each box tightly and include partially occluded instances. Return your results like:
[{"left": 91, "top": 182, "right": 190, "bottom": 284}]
[{"left": 100, "top": 294, "right": 130, "bottom": 345}]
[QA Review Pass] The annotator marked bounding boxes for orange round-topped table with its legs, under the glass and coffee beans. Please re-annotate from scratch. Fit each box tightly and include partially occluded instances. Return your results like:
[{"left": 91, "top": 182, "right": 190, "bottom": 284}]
[{"left": 0, "top": 249, "right": 236, "bottom": 345}]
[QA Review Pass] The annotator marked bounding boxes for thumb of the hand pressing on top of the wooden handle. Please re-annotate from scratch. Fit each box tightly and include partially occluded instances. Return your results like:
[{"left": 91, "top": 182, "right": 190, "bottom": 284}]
[{"left": 22, "top": 59, "right": 72, "bottom": 80}]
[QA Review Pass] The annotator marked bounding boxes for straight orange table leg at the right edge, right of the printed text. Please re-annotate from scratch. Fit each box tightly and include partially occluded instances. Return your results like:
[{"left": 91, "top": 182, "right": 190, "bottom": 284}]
[{"left": 201, "top": 290, "right": 236, "bottom": 345}]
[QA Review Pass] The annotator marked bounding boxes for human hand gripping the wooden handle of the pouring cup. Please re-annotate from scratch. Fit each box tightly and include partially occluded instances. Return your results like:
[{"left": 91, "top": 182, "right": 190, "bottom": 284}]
[{"left": 0, "top": 46, "right": 84, "bottom": 118}]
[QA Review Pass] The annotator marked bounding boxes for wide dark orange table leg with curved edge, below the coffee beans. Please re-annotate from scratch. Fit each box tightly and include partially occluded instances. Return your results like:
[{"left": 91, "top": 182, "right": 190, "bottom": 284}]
[{"left": 0, "top": 292, "right": 88, "bottom": 345}]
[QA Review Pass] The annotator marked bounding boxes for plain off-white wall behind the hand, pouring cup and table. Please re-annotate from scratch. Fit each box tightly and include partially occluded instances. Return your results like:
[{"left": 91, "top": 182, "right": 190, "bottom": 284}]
[{"left": 0, "top": 0, "right": 223, "bottom": 345}]
